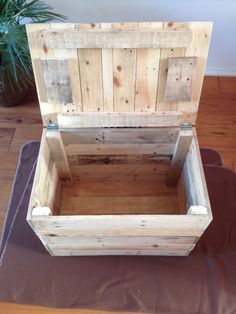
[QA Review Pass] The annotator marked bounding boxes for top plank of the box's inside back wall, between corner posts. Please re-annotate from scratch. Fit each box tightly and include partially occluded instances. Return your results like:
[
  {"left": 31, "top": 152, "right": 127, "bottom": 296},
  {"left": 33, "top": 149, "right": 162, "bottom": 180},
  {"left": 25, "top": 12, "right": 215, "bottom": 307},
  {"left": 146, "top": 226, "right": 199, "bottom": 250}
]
[{"left": 60, "top": 127, "right": 179, "bottom": 145}]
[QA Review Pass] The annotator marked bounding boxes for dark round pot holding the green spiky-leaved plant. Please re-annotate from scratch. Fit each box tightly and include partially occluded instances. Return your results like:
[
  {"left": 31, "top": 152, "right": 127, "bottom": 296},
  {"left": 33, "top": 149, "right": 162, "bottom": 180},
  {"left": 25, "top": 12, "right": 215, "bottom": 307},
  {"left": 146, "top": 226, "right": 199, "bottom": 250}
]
[{"left": 0, "top": 78, "right": 29, "bottom": 107}]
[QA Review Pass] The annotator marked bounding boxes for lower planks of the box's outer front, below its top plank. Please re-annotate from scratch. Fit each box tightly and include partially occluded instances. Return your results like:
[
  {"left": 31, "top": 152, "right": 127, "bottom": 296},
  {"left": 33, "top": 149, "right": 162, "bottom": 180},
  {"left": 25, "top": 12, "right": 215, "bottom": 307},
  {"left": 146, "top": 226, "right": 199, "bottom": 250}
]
[{"left": 42, "top": 236, "right": 197, "bottom": 255}]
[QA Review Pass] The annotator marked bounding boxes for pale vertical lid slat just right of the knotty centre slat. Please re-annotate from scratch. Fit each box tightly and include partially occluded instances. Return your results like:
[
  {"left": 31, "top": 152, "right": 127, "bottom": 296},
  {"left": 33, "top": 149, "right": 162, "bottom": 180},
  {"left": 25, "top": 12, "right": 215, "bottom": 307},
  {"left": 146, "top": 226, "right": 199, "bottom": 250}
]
[{"left": 135, "top": 23, "right": 162, "bottom": 111}]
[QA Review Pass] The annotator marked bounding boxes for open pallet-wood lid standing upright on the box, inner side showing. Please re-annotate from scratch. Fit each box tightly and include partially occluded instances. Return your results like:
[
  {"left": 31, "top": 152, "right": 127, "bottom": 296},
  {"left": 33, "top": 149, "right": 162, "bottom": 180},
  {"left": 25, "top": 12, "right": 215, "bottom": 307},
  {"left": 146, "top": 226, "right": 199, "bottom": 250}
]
[{"left": 27, "top": 22, "right": 212, "bottom": 128}]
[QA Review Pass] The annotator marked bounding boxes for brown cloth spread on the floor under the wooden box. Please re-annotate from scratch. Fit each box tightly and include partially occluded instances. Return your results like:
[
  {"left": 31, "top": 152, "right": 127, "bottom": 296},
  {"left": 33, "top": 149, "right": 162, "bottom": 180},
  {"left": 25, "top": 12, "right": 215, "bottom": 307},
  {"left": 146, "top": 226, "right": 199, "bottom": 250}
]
[{"left": 0, "top": 142, "right": 236, "bottom": 314}]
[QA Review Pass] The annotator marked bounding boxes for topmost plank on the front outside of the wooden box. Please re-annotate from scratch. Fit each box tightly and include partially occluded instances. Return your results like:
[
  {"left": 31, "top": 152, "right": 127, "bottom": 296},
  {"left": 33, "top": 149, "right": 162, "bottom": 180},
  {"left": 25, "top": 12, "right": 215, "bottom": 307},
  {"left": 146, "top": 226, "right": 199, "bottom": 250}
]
[{"left": 31, "top": 215, "right": 210, "bottom": 237}]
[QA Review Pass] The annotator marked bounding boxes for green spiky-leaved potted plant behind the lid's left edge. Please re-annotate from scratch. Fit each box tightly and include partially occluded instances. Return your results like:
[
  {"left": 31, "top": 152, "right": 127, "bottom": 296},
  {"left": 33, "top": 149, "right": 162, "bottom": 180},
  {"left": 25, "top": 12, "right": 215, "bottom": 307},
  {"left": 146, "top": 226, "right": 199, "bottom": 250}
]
[{"left": 0, "top": 0, "right": 65, "bottom": 106}]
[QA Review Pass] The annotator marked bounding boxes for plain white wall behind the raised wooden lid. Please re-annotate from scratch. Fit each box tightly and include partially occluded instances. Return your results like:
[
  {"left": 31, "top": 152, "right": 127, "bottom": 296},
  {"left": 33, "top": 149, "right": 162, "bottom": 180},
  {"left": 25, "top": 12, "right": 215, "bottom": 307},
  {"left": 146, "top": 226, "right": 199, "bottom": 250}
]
[{"left": 46, "top": 0, "right": 236, "bottom": 76}]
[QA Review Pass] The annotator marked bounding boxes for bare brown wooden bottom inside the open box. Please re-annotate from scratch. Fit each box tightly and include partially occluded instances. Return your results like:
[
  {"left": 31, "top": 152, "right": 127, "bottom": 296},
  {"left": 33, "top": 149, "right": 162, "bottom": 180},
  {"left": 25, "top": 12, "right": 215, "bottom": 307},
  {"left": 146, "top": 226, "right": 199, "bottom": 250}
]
[{"left": 59, "top": 162, "right": 180, "bottom": 215}]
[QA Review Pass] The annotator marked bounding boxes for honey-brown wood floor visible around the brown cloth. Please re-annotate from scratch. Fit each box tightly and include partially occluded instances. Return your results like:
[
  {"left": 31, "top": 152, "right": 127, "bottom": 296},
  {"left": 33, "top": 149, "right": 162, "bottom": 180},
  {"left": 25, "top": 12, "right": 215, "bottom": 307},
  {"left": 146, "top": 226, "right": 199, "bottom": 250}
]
[{"left": 0, "top": 77, "right": 236, "bottom": 314}]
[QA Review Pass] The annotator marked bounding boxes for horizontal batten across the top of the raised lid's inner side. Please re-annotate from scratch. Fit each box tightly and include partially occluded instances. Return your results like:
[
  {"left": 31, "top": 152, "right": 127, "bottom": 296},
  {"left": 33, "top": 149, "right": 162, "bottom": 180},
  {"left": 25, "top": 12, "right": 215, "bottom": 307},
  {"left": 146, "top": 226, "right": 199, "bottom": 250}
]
[{"left": 42, "top": 28, "right": 192, "bottom": 49}]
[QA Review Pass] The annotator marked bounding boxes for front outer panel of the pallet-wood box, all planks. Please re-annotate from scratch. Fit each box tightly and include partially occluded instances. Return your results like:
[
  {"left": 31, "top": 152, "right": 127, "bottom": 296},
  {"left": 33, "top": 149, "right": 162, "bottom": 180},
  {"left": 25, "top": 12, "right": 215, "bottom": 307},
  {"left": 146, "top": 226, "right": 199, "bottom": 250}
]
[{"left": 30, "top": 215, "right": 207, "bottom": 256}]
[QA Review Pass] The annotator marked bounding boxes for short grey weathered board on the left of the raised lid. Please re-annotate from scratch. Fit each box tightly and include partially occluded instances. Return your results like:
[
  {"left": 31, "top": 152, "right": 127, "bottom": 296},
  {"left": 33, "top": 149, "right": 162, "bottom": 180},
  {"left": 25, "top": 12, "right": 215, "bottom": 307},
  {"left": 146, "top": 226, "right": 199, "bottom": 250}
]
[{"left": 41, "top": 59, "right": 72, "bottom": 104}]
